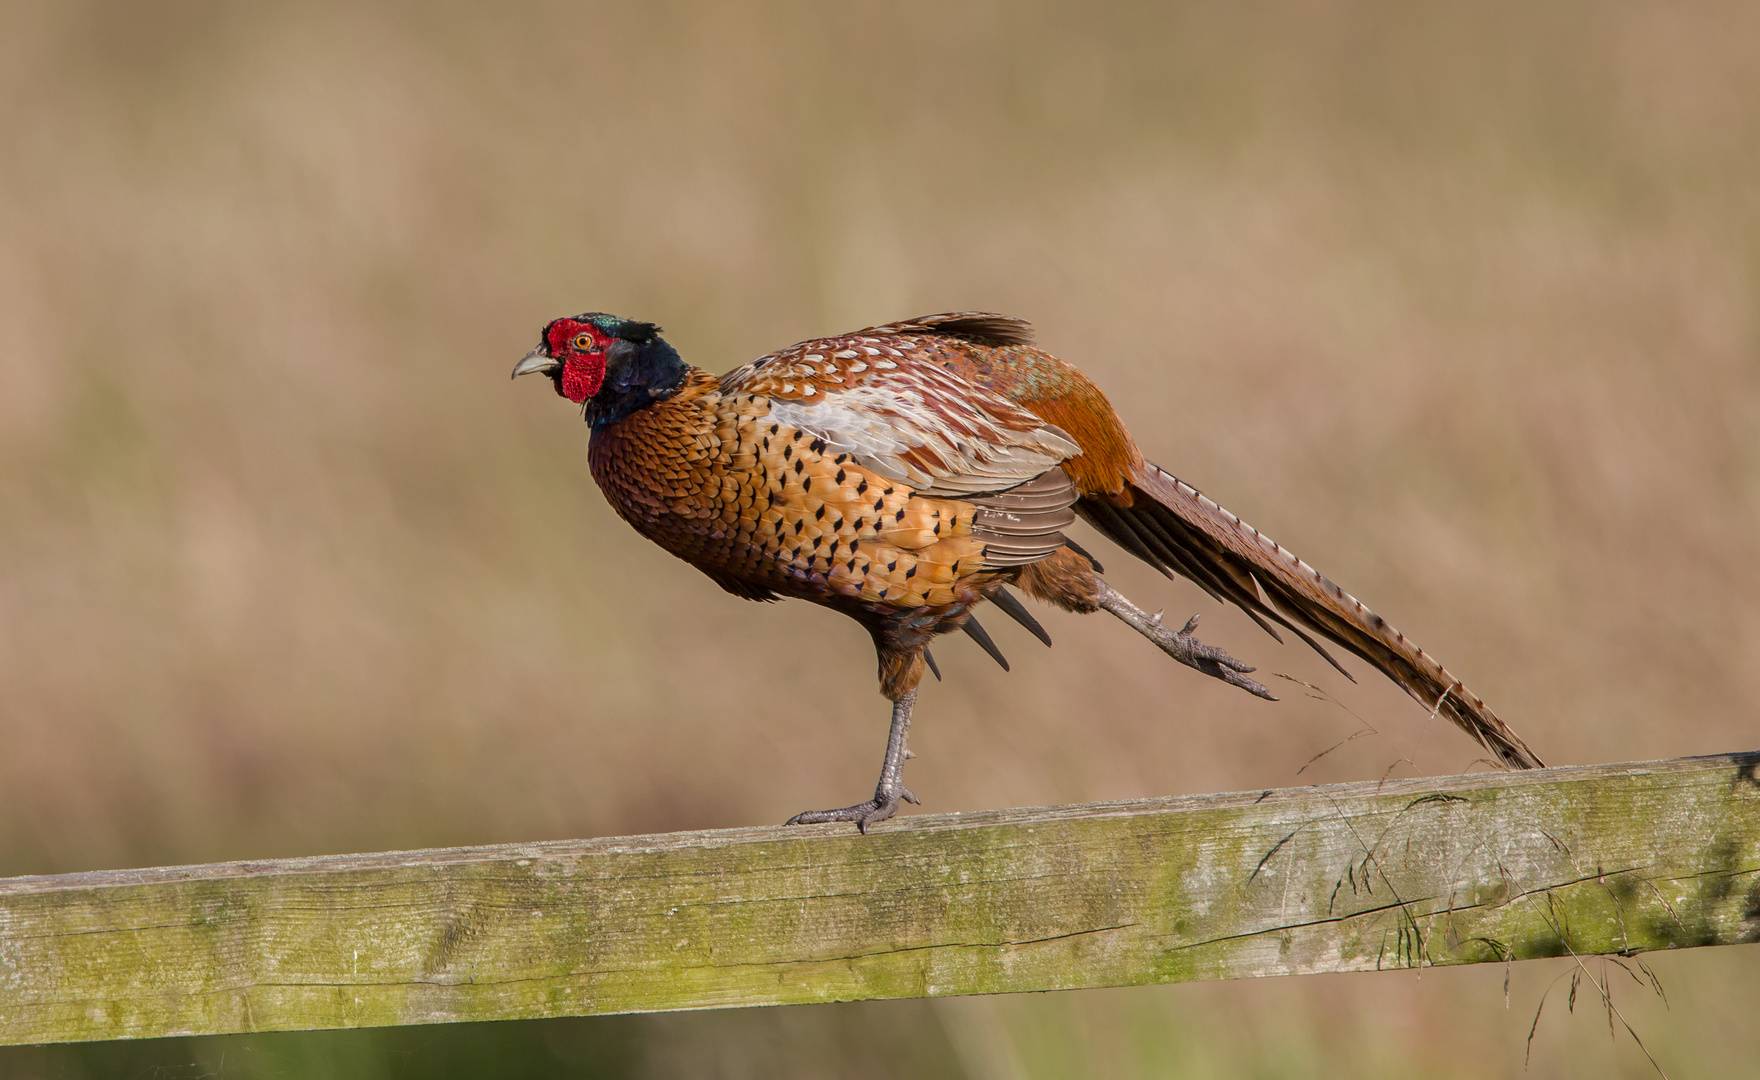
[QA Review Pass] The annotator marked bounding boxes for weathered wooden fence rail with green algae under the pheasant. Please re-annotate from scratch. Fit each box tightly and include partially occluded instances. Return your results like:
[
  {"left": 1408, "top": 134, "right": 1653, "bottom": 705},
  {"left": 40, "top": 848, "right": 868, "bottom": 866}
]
[{"left": 0, "top": 755, "right": 1760, "bottom": 1043}]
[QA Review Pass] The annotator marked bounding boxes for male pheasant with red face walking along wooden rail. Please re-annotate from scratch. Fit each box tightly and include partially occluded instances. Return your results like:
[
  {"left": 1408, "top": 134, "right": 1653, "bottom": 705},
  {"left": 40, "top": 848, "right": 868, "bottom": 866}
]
[{"left": 514, "top": 311, "right": 1542, "bottom": 832}]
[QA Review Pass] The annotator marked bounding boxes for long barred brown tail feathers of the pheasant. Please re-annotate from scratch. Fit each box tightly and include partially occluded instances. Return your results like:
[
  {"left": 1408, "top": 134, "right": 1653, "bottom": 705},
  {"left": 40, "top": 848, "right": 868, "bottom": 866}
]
[{"left": 1077, "top": 463, "right": 1542, "bottom": 769}]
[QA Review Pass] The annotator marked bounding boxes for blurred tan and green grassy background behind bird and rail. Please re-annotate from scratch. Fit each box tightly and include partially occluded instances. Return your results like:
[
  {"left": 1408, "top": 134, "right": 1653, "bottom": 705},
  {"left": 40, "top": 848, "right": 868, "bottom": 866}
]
[{"left": 0, "top": 0, "right": 1760, "bottom": 1080}]
